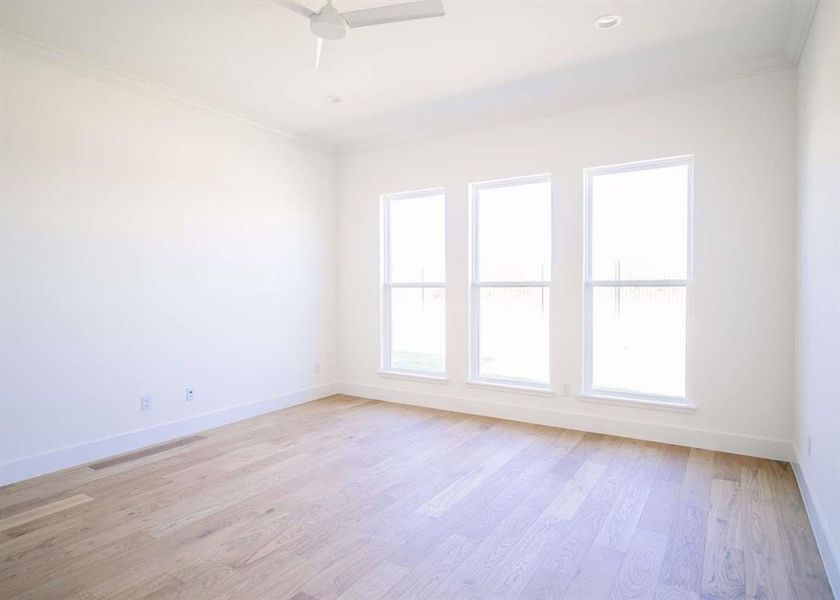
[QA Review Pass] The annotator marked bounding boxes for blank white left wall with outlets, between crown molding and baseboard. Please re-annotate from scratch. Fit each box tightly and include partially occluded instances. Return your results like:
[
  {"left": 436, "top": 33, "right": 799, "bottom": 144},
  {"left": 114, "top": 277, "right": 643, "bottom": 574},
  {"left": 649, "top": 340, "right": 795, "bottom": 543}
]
[{"left": 0, "top": 53, "right": 337, "bottom": 483}]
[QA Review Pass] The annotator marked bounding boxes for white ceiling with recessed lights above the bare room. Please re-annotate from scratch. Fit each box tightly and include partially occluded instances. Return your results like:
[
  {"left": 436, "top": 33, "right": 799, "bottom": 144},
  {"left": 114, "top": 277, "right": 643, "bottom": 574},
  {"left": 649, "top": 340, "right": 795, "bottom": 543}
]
[{"left": 0, "top": 0, "right": 815, "bottom": 146}]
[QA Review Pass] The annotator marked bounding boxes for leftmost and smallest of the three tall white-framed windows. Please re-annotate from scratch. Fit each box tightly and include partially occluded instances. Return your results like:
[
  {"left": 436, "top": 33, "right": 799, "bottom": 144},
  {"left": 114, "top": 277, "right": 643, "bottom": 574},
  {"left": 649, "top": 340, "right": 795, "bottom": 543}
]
[{"left": 382, "top": 189, "right": 446, "bottom": 375}]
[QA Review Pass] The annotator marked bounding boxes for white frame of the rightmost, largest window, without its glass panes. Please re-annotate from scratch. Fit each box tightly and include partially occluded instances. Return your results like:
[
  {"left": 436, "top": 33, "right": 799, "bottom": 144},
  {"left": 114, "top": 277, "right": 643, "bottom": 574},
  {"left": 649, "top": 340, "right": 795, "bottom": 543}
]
[{"left": 582, "top": 155, "right": 694, "bottom": 409}]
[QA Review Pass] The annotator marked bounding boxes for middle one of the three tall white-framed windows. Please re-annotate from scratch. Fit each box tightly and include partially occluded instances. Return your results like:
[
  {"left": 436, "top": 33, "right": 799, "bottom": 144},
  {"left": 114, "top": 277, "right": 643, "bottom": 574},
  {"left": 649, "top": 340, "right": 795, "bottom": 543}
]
[{"left": 470, "top": 175, "right": 551, "bottom": 387}]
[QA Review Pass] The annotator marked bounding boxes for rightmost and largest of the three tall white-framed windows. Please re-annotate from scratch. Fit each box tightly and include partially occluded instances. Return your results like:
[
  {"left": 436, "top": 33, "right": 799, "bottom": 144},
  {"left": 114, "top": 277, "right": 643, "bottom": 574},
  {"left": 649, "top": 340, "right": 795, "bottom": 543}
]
[{"left": 584, "top": 157, "right": 692, "bottom": 403}]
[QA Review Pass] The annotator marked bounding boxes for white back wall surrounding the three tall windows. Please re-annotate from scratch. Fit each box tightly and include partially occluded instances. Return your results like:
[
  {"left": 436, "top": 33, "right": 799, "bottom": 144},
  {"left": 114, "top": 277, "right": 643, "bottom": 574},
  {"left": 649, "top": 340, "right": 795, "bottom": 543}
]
[{"left": 339, "top": 70, "right": 796, "bottom": 458}]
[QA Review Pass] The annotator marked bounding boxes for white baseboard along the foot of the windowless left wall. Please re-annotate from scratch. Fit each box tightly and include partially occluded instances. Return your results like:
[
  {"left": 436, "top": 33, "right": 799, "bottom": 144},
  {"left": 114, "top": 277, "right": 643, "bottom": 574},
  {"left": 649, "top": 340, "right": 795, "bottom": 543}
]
[{"left": 0, "top": 383, "right": 335, "bottom": 486}]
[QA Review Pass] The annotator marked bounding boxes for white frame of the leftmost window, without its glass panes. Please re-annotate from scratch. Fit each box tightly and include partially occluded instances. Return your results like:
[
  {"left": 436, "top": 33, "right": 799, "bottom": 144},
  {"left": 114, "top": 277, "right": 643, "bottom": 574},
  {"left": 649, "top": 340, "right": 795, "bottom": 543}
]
[{"left": 379, "top": 187, "right": 448, "bottom": 381}]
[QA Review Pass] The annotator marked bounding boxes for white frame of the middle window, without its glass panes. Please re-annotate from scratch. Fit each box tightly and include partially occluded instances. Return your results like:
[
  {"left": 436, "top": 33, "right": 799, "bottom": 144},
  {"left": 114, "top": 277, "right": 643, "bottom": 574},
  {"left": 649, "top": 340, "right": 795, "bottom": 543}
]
[{"left": 467, "top": 173, "right": 554, "bottom": 394}]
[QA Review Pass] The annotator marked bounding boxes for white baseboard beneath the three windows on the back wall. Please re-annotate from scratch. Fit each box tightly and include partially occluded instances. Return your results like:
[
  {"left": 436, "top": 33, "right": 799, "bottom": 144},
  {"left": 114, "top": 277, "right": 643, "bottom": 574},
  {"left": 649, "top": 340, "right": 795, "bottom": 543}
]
[{"left": 337, "top": 383, "right": 792, "bottom": 461}]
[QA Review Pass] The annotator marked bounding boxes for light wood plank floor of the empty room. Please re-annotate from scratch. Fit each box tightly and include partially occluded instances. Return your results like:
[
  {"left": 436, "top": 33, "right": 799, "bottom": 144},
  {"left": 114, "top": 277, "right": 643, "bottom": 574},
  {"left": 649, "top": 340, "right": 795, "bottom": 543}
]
[{"left": 0, "top": 397, "right": 831, "bottom": 600}]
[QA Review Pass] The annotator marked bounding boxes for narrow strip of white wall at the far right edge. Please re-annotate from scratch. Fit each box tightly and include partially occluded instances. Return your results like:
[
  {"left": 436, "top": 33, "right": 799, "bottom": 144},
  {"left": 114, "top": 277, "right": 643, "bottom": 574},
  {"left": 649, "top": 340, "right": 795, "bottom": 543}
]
[{"left": 794, "top": 2, "right": 840, "bottom": 594}]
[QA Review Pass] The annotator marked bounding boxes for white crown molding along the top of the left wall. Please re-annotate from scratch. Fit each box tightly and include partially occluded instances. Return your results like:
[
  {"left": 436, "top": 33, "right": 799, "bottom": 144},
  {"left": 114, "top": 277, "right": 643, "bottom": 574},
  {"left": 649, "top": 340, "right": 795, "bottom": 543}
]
[{"left": 0, "top": 29, "right": 336, "bottom": 154}]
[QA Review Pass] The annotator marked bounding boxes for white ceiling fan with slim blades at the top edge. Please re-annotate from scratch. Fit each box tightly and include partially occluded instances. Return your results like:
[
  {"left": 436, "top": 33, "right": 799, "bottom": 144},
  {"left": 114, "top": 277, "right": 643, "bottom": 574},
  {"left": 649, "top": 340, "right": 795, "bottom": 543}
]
[{"left": 275, "top": 0, "right": 446, "bottom": 71}]
